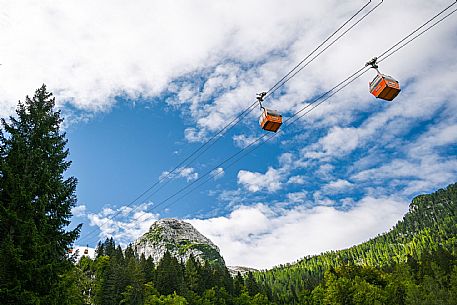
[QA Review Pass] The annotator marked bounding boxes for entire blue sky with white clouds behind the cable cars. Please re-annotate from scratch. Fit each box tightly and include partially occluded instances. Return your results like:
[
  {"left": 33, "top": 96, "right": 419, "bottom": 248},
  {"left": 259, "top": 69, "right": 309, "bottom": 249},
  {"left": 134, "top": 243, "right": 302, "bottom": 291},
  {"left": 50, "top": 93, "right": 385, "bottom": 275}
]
[{"left": 0, "top": 0, "right": 457, "bottom": 268}]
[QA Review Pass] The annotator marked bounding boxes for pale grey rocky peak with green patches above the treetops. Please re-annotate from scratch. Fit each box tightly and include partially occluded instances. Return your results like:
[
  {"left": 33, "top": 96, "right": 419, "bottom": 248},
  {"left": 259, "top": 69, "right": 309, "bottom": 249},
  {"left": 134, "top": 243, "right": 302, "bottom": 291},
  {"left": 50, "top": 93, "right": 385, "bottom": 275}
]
[{"left": 133, "top": 218, "right": 225, "bottom": 265}]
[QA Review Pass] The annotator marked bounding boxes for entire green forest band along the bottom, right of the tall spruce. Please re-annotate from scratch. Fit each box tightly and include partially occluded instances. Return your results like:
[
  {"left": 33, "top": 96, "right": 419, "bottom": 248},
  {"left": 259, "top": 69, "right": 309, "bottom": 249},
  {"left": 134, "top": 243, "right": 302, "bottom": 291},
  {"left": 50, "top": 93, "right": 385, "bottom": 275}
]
[{"left": 69, "top": 184, "right": 457, "bottom": 305}]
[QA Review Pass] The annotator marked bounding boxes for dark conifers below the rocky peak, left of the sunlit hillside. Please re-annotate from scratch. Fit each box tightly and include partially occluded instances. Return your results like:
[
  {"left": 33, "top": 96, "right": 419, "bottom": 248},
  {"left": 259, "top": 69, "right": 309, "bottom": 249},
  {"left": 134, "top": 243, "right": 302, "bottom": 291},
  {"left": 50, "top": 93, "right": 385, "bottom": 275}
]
[{"left": 81, "top": 239, "right": 273, "bottom": 305}]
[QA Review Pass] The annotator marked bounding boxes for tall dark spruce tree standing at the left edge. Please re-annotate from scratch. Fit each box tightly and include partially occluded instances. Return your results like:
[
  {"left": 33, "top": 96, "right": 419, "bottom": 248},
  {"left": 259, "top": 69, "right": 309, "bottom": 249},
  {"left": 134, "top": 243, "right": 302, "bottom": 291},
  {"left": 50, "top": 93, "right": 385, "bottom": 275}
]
[{"left": 0, "top": 85, "right": 80, "bottom": 304}]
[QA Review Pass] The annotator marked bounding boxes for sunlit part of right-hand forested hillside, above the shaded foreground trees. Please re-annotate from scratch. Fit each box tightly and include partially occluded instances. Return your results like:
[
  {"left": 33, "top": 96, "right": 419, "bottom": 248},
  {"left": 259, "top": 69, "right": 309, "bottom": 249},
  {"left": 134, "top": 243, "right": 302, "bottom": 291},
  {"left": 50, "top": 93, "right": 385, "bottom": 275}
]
[{"left": 256, "top": 183, "right": 457, "bottom": 304}]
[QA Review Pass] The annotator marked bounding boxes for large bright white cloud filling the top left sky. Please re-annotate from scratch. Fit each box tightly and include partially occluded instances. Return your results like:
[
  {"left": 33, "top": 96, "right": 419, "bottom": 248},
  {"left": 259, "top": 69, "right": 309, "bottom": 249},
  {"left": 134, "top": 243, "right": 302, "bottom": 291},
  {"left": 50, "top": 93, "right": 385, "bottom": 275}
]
[{"left": 0, "top": 1, "right": 320, "bottom": 113}]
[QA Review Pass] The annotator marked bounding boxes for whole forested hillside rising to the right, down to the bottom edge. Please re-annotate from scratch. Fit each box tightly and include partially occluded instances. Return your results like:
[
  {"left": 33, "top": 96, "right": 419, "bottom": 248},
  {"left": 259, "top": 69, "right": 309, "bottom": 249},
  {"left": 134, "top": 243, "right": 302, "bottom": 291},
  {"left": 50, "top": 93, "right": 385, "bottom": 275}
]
[{"left": 255, "top": 183, "right": 457, "bottom": 304}]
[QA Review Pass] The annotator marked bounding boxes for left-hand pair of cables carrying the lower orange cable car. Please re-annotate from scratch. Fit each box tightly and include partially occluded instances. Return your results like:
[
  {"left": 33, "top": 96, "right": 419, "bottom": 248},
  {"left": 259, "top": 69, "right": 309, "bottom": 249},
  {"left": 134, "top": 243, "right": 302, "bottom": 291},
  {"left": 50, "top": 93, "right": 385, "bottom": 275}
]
[{"left": 77, "top": 0, "right": 384, "bottom": 245}]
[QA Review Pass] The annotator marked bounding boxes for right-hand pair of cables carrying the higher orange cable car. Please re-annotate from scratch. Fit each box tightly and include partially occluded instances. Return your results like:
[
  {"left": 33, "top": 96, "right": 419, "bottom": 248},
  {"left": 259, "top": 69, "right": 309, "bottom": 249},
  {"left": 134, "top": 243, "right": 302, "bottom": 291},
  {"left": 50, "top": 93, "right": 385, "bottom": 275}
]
[{"left": 113, "top": 1, "right": 457, "bottom": 232}]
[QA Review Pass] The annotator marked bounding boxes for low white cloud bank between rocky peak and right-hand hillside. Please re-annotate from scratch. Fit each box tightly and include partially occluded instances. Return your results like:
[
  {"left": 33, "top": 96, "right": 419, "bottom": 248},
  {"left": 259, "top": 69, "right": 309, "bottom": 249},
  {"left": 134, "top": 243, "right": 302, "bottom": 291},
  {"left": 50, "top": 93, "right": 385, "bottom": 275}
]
[{"left": 189, "top": 197, "right": 407, "bottom": 268}]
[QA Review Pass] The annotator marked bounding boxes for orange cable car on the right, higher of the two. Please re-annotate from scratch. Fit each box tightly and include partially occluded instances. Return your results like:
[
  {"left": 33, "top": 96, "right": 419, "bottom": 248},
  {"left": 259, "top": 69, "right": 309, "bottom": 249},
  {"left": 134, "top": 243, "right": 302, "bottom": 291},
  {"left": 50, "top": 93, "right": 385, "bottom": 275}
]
[{"left": 366, "top": 57, "right": 401, "bottom": 101}]
